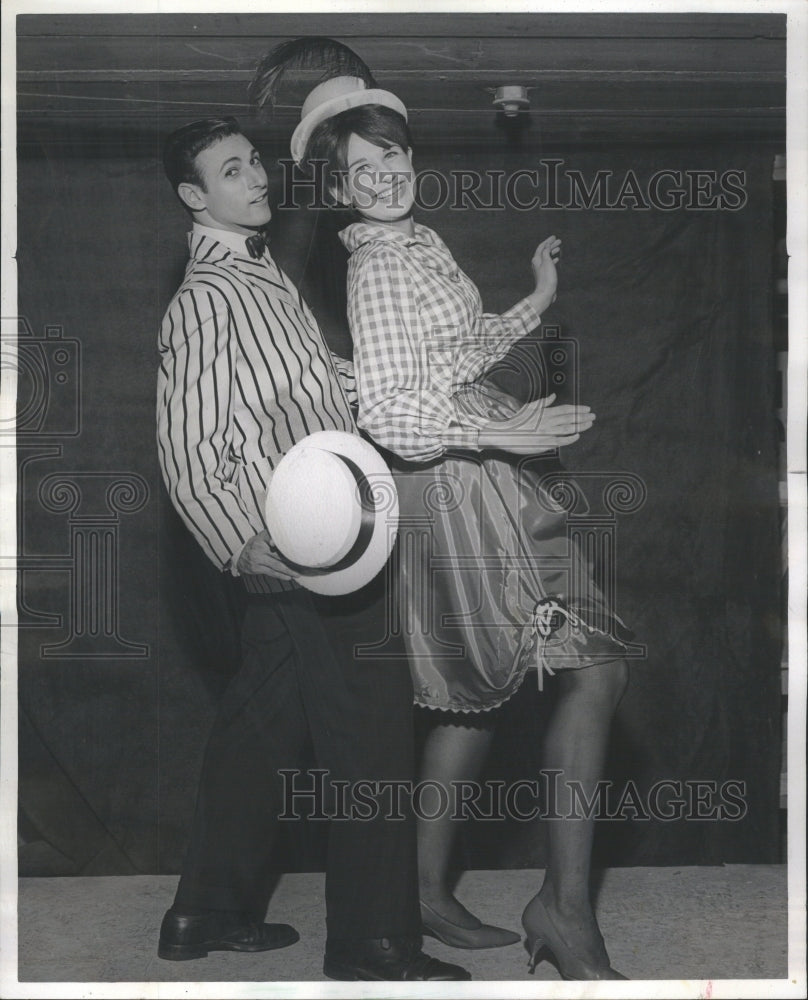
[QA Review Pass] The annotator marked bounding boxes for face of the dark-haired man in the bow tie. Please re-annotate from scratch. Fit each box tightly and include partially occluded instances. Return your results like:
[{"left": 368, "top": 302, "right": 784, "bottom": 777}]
[{"left": 185, "top": 135, "right": 272, "bottom": 233}]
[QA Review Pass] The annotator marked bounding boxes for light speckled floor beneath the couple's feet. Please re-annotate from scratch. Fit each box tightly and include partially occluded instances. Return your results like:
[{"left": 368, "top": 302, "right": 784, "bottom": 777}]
[{"left": 11, "top": 865, "right": 787, "bottom": 997}]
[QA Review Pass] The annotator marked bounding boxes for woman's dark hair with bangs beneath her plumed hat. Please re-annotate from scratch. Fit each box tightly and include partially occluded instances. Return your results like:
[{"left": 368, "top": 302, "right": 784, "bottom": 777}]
[{"left": 303, "top": 104, "right": 412, "bottom": 201}]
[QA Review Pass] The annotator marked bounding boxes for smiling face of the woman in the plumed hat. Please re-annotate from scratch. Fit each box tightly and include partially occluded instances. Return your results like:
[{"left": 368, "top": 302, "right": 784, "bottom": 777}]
[{"left": 344, "top": 135, "right": 415, "bottom": 223}]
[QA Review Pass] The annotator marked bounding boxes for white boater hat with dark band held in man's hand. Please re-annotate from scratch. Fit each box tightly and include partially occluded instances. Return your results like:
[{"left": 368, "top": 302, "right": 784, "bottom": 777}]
[{"left": 265, "top": 431, "right": 398, "bottom": 594}]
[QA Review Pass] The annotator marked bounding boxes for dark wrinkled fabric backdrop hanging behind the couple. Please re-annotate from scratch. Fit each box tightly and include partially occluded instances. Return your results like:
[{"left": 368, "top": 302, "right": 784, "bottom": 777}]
[{"left": 18, "top": 135, "right": 782, "bottom": 874}]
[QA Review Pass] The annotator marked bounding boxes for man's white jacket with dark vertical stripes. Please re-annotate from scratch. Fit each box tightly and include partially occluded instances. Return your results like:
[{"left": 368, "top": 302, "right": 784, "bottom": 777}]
[{"left": 157, "top": 225, "right": 355, "bottom": 591}]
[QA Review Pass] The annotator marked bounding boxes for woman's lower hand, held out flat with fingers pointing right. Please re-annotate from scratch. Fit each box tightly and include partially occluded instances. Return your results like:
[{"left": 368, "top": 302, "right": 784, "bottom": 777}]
[{"left": 478, "top": 393, "right": 595, "bottom": 455}]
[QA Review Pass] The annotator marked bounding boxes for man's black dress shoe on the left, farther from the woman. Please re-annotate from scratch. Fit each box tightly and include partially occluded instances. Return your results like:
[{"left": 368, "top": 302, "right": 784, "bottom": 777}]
[{"left": 157, "top": 909, "right": 300, "bottom": 962}]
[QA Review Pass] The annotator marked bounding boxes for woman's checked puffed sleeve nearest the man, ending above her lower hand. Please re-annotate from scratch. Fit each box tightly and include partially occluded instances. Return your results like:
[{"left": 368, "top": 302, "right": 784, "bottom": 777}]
[{"left": 348, "top": 246, "right": 483, "bottom": 462}]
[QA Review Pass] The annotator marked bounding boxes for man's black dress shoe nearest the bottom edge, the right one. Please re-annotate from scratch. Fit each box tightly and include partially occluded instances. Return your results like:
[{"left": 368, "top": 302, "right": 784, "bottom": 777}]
[{"left": 323, "top": 938, "right": 471, "bottom": 982}]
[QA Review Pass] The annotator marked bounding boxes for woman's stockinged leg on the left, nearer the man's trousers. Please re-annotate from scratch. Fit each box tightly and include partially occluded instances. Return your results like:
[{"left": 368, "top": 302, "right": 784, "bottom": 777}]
[{"left": 417, "top": 712, "right": 494, "bottom": 927}]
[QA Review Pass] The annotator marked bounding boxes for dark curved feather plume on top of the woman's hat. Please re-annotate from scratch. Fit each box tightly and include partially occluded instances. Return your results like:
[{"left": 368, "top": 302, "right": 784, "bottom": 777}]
[{"left": 248, "top": 35, "right": 377, "bottom": 108}]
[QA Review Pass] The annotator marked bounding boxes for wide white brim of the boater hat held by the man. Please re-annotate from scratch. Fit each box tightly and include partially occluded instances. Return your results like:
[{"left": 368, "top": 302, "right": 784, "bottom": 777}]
[{"left": 265, "top": 431, "right": 398, "bottom": 596}]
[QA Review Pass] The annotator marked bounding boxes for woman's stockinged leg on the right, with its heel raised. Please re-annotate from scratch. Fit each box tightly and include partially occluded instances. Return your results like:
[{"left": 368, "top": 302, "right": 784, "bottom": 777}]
[{"left": 524, "top": 660, "right": 628, "bottom": 969}]
